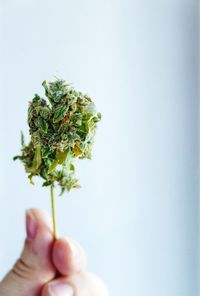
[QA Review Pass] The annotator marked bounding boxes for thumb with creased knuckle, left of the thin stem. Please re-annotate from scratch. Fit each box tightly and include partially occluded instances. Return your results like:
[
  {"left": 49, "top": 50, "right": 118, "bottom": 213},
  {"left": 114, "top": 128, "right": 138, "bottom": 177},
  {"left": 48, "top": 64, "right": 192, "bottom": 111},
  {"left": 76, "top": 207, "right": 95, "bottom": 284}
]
[{"left": 0, "top": 209, "right": 55, "bottom": 296}]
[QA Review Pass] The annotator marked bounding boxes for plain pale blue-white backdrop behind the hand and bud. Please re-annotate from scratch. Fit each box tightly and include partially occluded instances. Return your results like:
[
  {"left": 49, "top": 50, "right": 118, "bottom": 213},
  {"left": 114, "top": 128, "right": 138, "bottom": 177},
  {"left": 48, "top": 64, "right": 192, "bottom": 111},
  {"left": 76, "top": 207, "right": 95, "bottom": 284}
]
[{"left": 0, "top": 0, "right": 198, "bottom": 296}]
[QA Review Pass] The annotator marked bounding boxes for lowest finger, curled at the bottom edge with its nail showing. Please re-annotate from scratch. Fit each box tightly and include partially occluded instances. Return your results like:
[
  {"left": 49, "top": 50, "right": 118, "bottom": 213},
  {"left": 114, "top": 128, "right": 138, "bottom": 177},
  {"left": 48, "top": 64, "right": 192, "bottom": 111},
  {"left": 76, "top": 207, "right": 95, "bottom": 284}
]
[{"left": 42, "top": 272, "right": 108, "bottom": 296}]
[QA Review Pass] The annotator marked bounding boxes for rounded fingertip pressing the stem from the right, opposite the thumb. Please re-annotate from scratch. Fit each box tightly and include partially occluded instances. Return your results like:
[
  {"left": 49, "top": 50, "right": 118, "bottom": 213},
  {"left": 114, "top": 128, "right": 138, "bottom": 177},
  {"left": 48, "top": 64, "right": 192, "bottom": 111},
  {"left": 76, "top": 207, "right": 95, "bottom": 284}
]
[{"left": 52, "top": 238, "right": 87, "bottom": 275}]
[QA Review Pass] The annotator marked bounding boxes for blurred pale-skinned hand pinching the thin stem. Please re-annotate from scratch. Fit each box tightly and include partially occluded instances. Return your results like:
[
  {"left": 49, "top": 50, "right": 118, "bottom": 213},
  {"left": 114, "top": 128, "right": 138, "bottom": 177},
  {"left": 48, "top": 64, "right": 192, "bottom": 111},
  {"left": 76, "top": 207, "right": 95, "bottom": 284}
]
[{"left": 0, "top": 209, "right": 108, "bottom": 296}]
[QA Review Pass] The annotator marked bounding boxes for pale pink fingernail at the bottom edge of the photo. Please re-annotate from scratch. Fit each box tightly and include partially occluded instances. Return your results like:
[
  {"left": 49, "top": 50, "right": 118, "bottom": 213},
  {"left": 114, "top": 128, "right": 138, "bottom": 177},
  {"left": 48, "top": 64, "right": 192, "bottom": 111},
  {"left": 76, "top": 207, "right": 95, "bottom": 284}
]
[{"left": 48, "top": 283, "right": 73, "bottom": 296}]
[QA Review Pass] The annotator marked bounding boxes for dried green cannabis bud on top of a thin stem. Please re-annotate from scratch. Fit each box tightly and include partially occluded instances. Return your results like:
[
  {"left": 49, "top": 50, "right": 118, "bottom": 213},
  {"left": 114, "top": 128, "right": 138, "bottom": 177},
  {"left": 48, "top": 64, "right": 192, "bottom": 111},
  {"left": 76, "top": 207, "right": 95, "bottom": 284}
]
[{"left": 14, "top": 79, "right": 101, "bottom": 194}]
